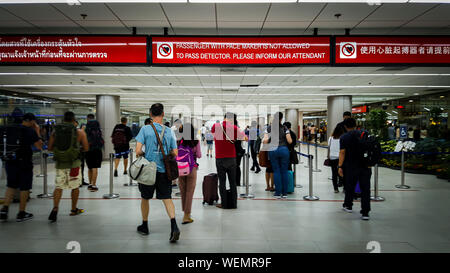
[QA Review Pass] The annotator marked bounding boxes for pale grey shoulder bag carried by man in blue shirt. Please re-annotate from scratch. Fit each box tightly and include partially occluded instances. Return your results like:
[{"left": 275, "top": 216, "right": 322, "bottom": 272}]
[{"left": 128, "top": 156, "right": 157, "bottom": 186}]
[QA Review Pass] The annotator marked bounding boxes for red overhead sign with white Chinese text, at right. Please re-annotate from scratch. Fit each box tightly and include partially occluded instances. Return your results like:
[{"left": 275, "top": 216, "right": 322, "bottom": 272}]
[{"left": 336, "top": 36, "right": 450, "bottom": 64}]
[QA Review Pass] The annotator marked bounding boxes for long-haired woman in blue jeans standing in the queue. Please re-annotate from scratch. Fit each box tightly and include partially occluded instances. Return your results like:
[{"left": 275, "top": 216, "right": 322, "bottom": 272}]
[{"left": 263, "top": 112, "right": 293, "bottom": 199}]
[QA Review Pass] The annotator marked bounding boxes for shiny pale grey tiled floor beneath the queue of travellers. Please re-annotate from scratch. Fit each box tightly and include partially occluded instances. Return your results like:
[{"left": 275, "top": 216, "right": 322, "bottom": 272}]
[{"left": 0, "top": 143, "right": 450, "bottom": 253}]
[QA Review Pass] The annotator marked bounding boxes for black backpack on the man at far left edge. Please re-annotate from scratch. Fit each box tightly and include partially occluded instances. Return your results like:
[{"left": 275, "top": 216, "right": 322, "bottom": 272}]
[{"left": 0, "top": 124, "right": 25, "bottom": 161}]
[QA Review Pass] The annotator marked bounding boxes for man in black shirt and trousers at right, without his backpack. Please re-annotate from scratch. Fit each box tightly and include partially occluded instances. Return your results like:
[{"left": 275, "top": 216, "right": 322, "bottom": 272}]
[{"left": 338, "top": 118, "right": 372, "bottom": 220}]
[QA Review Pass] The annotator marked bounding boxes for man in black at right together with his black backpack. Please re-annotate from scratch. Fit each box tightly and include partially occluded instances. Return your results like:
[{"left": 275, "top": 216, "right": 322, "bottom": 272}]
[{"left": 338, "top": 118, "right": 381, "bottom": 220}]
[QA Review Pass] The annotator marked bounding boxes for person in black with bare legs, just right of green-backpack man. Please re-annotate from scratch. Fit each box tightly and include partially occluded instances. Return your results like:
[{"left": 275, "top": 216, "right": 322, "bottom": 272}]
[{"left": 84, "top": 114, "right": 105, "bottom": 192}]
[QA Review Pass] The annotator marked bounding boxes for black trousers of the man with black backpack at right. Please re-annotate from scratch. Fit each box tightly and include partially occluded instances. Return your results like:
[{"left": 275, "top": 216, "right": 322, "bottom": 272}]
[{"left": 344, "top": 168, "right": 372, "bottom": 213}]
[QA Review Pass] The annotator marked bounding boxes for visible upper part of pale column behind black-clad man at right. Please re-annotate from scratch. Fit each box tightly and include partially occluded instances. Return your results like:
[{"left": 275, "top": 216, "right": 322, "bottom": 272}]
[{"left": 327, "top": 96, "right": 352, "bottom": 137}]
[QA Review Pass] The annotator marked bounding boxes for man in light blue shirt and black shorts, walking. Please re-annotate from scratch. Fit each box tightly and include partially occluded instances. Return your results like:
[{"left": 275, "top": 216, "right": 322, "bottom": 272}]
[{"left": 136, "top": 103, "right": 180, "bottom": 242}]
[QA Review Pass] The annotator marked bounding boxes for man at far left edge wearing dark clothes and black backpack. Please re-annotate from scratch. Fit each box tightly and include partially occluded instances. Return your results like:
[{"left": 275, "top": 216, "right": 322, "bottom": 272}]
[{"left": 0, "top": 113, "right": 43, "bottom": 222}]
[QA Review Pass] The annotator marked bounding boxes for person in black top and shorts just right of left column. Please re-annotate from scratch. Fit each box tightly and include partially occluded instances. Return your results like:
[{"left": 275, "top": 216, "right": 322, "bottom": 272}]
[{"left": 111, "top": 117, "right": 133, "bottom": 177}]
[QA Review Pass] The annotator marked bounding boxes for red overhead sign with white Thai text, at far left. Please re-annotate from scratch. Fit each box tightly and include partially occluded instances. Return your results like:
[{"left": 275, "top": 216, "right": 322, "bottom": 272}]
[{"left": 0, "top": 35, "right": 148, "bottom": 64}]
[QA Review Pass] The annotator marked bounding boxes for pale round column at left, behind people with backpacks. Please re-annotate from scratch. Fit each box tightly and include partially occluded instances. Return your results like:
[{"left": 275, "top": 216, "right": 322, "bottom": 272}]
[{"left": 96, "top": 95, "right": 120, "bottom": 159}]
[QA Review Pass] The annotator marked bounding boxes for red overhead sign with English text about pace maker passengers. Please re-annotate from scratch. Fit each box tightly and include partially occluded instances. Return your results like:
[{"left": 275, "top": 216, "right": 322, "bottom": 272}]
[{"left": 152, "top": 37, "right": 330, "bottom": 65}]
